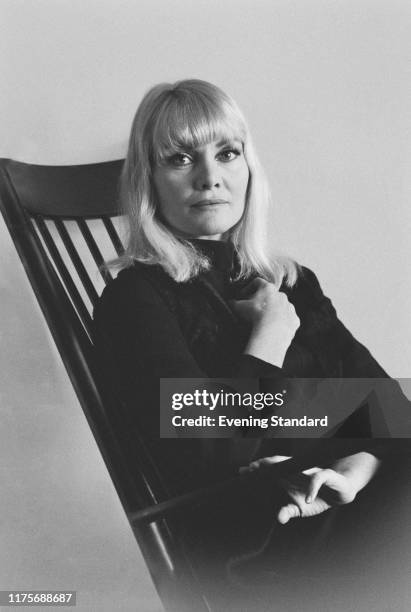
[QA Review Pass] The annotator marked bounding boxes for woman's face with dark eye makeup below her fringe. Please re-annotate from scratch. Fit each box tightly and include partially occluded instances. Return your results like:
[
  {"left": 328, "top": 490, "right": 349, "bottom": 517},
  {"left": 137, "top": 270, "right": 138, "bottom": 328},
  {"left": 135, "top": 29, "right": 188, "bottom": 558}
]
[{"left": 153, "top": 139, "right": 250, "bottom": 240}]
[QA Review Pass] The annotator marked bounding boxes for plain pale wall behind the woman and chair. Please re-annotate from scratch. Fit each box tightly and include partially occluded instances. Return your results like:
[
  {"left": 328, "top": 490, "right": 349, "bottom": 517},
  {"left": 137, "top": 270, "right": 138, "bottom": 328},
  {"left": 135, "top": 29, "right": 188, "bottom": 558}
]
[{"left": 0, "top": 0, "right": 411, "bottom": 611}]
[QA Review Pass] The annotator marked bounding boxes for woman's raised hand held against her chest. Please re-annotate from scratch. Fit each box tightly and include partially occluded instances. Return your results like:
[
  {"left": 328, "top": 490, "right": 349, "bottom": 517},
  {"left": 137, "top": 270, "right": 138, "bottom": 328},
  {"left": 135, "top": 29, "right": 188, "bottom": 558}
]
[{"left": 232, "top": 278, "right": 300, "bottom": 368}]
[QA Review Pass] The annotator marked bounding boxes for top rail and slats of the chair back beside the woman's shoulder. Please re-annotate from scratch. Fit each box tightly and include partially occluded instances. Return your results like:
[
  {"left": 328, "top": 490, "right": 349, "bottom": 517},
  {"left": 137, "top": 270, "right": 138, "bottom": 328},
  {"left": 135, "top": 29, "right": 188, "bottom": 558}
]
[{"left": 4, "top": 160, "right": 123, "bottom": 334}]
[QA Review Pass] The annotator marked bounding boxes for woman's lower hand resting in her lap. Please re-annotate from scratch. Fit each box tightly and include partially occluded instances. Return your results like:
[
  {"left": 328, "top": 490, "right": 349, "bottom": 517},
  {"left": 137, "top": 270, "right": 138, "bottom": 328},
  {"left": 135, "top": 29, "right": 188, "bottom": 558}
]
[{"left": 246, "top": 452, "right": 380, "bottom": 525}]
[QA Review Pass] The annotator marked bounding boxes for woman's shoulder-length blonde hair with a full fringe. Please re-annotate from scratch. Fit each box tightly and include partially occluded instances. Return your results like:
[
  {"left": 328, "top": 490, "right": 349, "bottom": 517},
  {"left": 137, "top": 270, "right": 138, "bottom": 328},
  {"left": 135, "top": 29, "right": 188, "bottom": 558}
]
[{"left": 114, "top": 79, "right": 297, "bottom": 286}]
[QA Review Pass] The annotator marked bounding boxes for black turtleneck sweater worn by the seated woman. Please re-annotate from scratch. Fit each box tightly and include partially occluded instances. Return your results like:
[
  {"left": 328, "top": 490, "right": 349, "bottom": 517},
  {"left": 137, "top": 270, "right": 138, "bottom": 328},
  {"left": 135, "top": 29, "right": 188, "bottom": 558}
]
[{"left": 94, "top": 240, "right": 408, "bottom": 491}]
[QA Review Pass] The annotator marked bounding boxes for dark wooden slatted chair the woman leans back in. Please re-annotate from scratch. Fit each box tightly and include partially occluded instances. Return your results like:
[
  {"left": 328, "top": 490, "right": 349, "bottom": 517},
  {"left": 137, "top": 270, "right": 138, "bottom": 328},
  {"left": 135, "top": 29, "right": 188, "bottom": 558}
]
[{"left": 0, "top": 159, "right": 209, "bottom": 611}]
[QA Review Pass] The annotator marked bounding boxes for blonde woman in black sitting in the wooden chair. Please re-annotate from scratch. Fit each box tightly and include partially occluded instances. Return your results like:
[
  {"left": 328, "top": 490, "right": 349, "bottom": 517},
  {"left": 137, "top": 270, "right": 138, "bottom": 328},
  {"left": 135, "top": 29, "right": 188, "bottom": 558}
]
[{"left": 95, "top": 79, "right": 408, "bottom": 584}]
